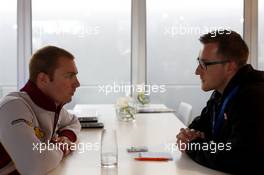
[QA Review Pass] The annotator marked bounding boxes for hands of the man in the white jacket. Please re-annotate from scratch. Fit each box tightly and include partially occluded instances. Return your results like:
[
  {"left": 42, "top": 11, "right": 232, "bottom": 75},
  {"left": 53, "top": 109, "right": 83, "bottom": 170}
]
[{"left": 51, "top": 136, "right": 73, "bottom": 157}]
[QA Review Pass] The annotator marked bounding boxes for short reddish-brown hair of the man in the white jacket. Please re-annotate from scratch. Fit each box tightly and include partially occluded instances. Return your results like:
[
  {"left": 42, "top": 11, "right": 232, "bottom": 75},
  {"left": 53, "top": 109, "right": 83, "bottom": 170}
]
[{"left": 29, "top": 46, "right": 74, "bottom": 83}]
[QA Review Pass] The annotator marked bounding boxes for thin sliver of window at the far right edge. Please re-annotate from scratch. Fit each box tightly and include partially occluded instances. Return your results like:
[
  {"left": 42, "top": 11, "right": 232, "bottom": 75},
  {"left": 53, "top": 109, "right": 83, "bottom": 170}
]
[{"left": 258, "top": 0, "right": 264, "bottom": 70}]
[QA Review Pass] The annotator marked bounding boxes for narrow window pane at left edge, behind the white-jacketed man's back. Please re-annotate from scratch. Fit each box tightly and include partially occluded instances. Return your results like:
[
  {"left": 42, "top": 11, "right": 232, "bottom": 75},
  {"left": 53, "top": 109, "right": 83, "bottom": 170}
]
[{"left": 0, "top": 0, "right": 17, "bottom": 97}]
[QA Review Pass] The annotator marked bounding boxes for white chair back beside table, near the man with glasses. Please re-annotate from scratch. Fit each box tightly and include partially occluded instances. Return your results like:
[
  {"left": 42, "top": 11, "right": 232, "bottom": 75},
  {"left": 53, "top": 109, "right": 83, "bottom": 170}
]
[{"left": 177, "top": 102, "right": 192, "bottom": 126}]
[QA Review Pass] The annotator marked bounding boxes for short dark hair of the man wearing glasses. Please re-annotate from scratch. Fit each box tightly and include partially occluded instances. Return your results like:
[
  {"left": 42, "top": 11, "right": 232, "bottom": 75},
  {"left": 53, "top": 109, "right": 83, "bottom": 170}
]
[{"left": 199, "top": 30, "right": 249, "bottom": 67}]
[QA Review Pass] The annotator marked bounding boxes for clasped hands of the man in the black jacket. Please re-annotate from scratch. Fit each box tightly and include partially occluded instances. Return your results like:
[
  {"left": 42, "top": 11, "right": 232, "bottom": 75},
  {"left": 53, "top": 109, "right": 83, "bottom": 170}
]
[{"left": 176, "top": 128, "right": 204, "bottom": 152}]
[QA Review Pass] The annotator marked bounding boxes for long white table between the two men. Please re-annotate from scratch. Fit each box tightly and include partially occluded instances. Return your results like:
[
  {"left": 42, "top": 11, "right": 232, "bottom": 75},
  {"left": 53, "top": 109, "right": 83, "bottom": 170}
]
[{"left": 50, "top": 105, "right": 227, "bottom": 175}]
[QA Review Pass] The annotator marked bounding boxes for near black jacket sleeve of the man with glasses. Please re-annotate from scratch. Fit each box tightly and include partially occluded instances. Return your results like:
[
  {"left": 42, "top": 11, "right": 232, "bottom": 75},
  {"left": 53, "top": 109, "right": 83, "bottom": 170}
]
[{"left": 186, "top": 89, "right": 264, "bottom": 174}]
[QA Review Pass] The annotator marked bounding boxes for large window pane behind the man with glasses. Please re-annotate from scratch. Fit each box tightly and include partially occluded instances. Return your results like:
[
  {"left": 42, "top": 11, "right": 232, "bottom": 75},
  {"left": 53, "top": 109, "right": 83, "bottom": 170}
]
[{"left": 147, "top": 0, "right": 243, "bottom": 115}]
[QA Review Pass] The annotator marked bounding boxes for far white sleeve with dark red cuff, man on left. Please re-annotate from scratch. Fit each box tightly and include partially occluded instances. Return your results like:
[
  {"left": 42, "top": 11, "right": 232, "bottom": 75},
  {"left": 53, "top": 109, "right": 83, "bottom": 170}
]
[{"left": 57, "top": 108, "right": 81, "bottom": 142}]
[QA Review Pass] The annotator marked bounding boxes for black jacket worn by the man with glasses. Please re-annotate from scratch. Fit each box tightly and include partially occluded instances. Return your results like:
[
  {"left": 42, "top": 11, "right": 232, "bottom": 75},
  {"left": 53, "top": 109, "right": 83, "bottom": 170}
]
[{"left": 186, "top": 65, "right": 264, "bottom": 174}]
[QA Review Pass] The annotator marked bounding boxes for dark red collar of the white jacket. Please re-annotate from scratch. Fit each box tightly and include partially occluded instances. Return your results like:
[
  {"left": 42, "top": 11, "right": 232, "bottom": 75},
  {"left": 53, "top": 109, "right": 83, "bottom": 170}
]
[{"left": 20, "top": 80, "right": 63, "bottom": 112}]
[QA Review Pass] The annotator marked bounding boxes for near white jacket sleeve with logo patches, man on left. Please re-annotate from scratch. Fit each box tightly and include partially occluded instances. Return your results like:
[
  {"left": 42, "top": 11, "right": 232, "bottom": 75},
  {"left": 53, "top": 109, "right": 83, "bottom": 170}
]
[{"left": 0, "top": 99, "right": 63, "bottom": 175}]
